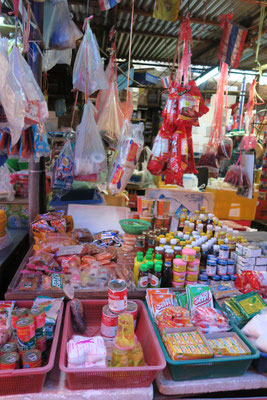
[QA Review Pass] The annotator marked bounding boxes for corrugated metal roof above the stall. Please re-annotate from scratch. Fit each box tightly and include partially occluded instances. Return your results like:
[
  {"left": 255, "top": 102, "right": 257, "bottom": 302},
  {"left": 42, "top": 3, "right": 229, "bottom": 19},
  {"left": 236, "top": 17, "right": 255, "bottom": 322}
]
[{"left": 69, "top": 0, "right": 267, "bottom": 69}]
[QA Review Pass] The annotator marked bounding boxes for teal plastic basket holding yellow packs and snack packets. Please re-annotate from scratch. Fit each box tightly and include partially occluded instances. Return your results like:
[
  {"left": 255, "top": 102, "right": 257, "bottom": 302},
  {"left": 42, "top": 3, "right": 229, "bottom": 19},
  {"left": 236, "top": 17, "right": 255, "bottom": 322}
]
[{"left": 148, "top": 304, "right": 260, "bottom": 381}]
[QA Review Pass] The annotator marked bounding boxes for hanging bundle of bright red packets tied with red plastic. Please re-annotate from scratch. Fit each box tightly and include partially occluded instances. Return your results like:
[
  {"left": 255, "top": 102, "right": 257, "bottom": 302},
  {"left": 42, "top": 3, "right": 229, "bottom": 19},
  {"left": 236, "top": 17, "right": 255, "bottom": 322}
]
[{"left": 147, "top": 16, "right": 208, "bottom": 186}]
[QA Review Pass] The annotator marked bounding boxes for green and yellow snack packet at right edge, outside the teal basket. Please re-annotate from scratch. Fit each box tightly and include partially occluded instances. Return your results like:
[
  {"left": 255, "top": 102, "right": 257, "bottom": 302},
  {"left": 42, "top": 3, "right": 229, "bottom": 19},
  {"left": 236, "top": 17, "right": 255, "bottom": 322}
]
[{"left": 233, "top": 292, "right": 266, "bottom": 319}]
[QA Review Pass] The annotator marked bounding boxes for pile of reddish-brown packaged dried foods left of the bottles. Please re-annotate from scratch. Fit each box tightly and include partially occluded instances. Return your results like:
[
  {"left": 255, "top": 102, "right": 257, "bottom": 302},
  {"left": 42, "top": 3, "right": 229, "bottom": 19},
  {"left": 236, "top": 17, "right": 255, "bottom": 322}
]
[{"left": 14, "top": 211, "right": 135, "bottom": 291}]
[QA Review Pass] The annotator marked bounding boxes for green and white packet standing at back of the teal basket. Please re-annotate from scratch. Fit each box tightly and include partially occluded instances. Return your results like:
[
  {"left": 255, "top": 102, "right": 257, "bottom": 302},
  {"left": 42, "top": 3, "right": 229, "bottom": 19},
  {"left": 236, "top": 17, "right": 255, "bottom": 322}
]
[{"left": 186, "top": 285, "right": 213, "bottom": 312}]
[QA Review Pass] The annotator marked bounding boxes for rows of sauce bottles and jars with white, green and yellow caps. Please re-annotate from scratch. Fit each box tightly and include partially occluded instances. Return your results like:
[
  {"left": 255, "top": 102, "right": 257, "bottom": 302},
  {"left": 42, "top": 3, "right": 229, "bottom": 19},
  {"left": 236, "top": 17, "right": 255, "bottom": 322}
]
[{"left": 134, "top": 206, "right": 245, "bottom": 288}]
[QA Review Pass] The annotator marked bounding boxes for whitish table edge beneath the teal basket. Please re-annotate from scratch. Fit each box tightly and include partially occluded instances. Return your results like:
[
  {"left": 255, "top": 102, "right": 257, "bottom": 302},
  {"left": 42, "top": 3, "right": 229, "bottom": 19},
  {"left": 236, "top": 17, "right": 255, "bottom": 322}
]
[{"left": 156, "top": 368, "right": 267, "bottom": 397}]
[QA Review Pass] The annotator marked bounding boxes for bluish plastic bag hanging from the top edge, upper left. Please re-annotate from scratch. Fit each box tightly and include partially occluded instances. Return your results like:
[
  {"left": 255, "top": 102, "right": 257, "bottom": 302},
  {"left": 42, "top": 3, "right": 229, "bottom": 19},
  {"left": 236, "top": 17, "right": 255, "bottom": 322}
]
[{"left": 44, "top": 0, "right": 82, "bottom": 50}]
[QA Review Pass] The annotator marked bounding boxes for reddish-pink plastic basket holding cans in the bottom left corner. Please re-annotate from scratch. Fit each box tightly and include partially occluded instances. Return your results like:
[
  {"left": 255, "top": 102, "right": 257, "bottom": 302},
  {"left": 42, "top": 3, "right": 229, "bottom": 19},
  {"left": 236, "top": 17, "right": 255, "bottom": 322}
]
[{"left": 0, "top": 300, "right": 63, "bottom": 396}]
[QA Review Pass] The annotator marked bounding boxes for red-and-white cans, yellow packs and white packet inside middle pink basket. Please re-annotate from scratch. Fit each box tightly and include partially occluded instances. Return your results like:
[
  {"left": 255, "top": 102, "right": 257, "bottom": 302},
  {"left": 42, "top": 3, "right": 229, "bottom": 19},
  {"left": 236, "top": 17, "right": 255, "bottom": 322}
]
[{"left": 67, "top": 280, "right": 145, "bottom": 368}]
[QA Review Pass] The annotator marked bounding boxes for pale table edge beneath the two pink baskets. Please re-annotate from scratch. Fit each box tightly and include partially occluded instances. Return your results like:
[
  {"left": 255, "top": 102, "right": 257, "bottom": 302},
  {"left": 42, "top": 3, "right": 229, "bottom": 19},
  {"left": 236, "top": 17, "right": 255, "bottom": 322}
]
[{"left": 4, "top": 367, "right": 153, "bottom": 400}]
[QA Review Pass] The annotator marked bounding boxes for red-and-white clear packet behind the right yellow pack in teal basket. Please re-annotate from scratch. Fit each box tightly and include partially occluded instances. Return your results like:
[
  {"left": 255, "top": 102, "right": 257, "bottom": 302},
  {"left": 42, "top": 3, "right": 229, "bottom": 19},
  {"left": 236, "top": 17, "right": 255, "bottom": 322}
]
[{"left": 191, "top": 307, "right": 231, "bottom": 333}]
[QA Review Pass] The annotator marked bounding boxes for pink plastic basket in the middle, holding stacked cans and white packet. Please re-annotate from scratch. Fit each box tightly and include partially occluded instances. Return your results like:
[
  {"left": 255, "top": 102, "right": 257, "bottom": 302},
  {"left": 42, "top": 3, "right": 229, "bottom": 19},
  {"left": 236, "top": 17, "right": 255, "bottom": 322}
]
[{"left": 59, "top": 300, "right": 166, "bottom": 389}]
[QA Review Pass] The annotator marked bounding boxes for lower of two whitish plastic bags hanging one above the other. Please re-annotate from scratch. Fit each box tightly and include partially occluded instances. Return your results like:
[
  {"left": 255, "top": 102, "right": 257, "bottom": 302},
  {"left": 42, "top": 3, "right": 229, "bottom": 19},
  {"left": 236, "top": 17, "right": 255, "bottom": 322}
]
[{"left": 74, "top": 100, "right": 107, "bottom": 181}]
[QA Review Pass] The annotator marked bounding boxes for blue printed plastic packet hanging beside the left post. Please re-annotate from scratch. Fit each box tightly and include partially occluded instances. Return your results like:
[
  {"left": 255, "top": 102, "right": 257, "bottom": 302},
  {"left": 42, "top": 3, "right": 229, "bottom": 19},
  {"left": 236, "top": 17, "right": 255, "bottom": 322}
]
[{"left": 52, "top": 140, "right": 74, "bottom": 198}]
